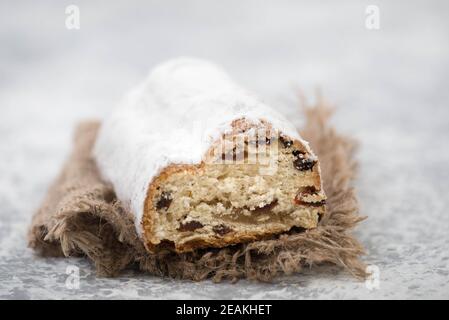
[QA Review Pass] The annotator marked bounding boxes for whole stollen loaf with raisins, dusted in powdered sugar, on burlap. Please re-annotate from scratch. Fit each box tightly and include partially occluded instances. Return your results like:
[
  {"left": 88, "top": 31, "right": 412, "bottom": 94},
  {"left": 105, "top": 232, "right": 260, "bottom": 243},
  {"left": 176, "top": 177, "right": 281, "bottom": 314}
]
[{"left": 94, "top": 58, "right": 325, "bottom": 252}]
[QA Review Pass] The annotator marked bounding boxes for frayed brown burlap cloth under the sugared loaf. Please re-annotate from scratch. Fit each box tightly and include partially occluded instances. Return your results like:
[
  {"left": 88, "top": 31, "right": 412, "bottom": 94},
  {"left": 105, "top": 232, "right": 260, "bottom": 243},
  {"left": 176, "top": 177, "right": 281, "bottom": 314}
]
[{"left": 29, "top": 105, "right": 365, "bottom": 282}]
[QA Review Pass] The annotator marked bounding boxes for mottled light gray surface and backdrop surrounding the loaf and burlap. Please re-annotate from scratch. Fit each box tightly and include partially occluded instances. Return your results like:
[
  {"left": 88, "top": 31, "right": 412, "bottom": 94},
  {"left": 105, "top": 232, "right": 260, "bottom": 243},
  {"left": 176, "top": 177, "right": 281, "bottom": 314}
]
[{"left": 0, "top": 0, "right": 449, "bottom": 299}]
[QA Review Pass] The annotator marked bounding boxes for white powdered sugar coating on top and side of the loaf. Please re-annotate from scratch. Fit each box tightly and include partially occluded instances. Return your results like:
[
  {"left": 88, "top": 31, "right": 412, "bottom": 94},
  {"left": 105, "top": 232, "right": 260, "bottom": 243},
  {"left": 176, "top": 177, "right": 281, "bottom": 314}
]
[{"left": 94, "top": 58, "right": 307, "bottom": 234}]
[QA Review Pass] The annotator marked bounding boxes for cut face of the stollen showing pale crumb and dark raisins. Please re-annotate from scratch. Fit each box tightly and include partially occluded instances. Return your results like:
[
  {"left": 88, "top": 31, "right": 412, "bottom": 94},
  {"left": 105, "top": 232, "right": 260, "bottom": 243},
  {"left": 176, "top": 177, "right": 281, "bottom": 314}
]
[{"left": 142, "top": 123, "right": 326, "bottom": 252}]
